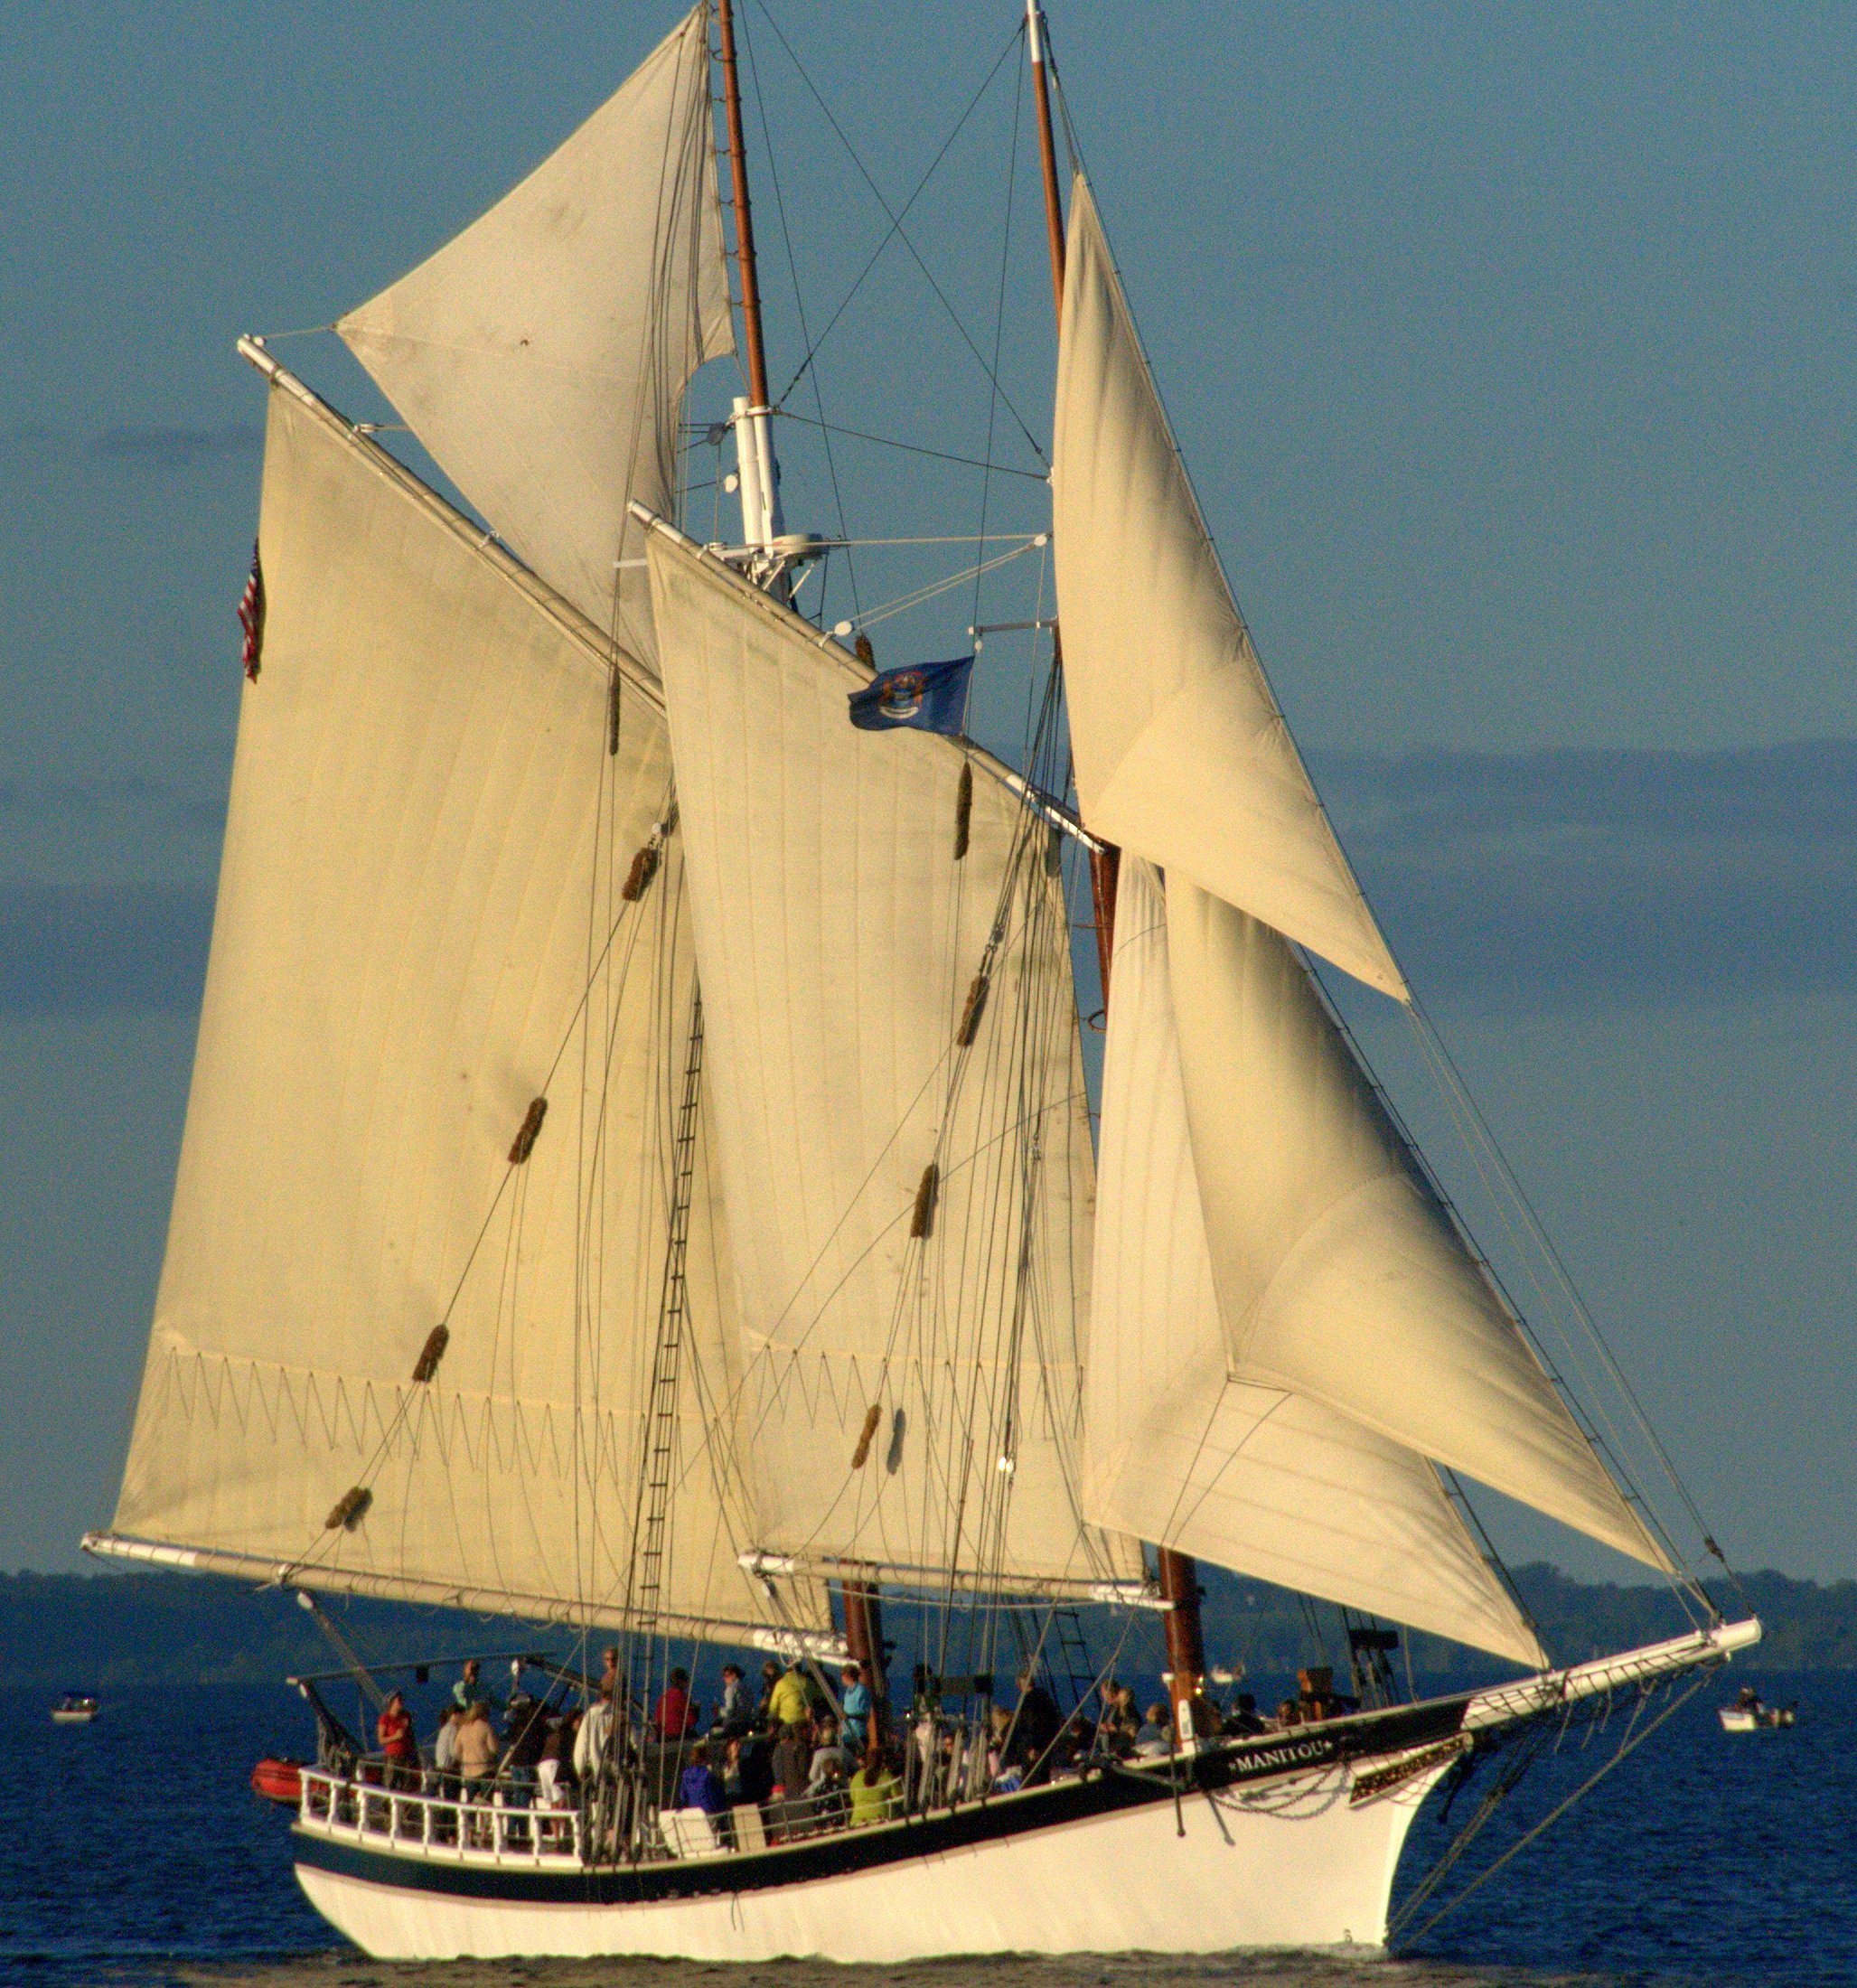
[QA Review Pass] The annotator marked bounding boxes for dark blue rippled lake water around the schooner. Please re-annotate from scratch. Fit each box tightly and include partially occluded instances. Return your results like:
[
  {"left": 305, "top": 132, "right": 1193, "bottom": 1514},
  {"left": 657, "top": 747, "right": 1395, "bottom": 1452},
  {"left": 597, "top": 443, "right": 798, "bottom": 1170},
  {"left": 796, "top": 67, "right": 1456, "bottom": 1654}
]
[{"left": 0, "top": 1674, "right": 1857, "bottom": 1988}]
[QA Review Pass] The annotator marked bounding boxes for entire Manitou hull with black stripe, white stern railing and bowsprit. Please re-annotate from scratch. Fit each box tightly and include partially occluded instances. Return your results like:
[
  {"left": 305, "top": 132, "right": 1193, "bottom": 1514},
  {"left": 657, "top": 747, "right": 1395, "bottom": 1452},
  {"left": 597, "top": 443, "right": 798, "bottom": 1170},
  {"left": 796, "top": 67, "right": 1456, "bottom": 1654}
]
[{"left": 280, "top": 1622, "right": 1759, "bottom": 1962}]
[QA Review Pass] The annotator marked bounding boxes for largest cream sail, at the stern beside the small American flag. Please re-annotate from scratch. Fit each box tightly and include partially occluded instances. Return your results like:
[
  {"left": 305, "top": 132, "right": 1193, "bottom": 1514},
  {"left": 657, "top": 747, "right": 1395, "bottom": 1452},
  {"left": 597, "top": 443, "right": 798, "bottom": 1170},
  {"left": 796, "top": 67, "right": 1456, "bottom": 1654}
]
[{"left": 116, "top": 388, "right": 827, "bottom": 1628}]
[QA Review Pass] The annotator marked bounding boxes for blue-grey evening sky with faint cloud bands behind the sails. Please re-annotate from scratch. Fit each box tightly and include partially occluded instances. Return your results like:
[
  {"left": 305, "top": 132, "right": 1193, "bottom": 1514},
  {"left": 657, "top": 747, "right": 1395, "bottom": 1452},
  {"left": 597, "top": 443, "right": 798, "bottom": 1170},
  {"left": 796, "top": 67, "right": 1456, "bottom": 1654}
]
[{"left": 0, "top": 0, "right": 1857, "bottom": 1574}]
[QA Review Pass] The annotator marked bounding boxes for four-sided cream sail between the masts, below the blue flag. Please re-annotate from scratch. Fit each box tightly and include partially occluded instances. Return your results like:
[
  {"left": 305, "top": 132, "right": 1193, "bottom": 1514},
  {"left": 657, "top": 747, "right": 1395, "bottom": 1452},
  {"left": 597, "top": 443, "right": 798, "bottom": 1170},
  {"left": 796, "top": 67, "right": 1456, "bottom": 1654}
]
[{"left": 648, "top": 535, "right": 1138, "bottom": 1584}]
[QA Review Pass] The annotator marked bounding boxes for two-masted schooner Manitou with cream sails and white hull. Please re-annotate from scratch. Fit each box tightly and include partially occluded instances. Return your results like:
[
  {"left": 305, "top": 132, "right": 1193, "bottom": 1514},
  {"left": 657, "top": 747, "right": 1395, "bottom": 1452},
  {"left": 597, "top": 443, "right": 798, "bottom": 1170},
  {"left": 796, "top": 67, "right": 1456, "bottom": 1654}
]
[{"left": 86, "top": 0, "right": 1759, "bottom": 1960}]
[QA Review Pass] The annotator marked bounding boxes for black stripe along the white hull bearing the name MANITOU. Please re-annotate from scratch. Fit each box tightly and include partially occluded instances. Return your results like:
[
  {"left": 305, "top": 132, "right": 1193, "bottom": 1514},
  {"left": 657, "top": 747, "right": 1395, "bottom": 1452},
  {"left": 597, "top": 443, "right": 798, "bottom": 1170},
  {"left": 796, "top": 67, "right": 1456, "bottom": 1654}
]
[{"left": 295, "top": 1698, "right": 1466, "bottom": 1905}]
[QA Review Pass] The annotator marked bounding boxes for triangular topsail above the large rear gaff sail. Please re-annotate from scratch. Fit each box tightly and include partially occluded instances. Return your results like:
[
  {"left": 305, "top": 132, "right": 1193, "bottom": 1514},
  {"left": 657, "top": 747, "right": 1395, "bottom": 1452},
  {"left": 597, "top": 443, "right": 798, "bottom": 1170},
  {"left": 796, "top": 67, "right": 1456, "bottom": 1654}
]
[{"left": 336, "top": 6, "right": 734, "bottom": 660}]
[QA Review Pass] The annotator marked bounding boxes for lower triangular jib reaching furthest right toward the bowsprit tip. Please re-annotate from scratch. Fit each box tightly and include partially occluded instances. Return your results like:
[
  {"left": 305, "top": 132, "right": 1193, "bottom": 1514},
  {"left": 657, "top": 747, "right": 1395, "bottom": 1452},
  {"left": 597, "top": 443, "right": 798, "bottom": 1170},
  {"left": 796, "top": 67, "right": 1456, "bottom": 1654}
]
[{"left": 1168, "top": 877, "right": 1668, "bottom": 1569}]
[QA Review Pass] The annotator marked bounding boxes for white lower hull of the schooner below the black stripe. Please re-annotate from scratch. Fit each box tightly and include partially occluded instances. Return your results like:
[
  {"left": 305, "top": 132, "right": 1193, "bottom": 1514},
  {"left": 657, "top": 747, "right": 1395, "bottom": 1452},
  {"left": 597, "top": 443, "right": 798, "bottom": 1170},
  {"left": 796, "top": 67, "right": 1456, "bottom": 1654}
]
[{"left": 298, "top": 1758, "right": 1449, "bottom": 1962}]
